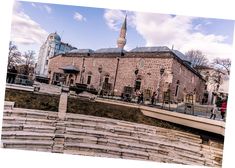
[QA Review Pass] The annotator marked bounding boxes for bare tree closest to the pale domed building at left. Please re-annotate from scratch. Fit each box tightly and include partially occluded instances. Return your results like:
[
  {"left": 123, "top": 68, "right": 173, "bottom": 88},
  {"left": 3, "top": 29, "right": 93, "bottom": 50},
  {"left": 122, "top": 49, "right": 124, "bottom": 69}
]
[{"left": 22, "top": 50, "right": 35, "bottom": 75}]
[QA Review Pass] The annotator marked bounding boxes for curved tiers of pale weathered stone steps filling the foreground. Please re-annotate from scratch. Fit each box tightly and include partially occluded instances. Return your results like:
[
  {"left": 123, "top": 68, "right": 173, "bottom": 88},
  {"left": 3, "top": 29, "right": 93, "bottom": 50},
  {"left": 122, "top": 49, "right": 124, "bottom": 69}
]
[{"left": 2, "top": 108, "right": 223, "bottom": 167}]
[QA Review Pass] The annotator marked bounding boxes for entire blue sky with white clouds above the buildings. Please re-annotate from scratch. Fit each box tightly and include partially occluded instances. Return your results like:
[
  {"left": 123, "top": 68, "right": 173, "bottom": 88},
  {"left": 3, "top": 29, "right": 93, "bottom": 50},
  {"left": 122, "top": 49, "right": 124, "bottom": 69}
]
[{"left": 11, "top": 2, "right": 234, "bottom": 59}]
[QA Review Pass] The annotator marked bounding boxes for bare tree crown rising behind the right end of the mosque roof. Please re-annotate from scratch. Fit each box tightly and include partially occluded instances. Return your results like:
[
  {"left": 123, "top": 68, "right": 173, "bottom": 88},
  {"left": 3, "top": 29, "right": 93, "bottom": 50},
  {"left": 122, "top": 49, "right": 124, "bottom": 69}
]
[{"left": 185, "top": 50, "right": 208, "bottom": 67}]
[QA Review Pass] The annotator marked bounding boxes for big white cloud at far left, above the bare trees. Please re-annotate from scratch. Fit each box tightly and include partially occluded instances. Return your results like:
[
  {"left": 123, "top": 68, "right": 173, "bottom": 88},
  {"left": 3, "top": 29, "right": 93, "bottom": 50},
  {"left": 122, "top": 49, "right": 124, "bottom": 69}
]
[{"left": 11, "top": 2, "right": 48, "bottom": 45}]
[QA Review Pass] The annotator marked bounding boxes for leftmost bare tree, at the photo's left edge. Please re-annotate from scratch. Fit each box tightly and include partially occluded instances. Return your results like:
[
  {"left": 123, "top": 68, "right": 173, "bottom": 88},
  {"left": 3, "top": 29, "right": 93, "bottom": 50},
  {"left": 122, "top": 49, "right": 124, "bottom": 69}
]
[{"left": 7, "top": 41, "right": 22, "bottom": 69}]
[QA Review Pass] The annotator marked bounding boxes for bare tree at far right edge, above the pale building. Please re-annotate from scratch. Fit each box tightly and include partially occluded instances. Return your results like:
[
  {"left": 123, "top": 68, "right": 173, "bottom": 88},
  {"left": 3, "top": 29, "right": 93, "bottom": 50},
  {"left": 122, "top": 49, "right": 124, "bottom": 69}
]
[{"left": 212, "top": 58, "right": 231, "bottom": 75}]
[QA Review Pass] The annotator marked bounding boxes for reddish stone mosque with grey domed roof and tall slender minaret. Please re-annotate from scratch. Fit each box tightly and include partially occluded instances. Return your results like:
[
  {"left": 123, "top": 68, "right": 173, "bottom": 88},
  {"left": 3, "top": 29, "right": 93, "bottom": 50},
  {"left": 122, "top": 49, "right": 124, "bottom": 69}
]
[{"left": 43, "top": 17, "right": 205, "bottom": 102}]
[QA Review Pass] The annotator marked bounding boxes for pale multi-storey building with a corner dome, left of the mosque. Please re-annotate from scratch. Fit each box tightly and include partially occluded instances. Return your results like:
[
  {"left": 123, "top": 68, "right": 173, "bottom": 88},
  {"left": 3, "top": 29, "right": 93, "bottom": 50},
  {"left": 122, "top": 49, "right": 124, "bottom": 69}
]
[{"left": 35, "top": 32, "right": 76, "bottom": 78}]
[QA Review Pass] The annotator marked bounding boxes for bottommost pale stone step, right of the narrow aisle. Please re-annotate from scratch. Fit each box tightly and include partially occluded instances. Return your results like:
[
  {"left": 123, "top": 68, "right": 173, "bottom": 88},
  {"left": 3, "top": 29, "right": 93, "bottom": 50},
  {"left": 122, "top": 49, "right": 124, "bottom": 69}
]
[{"left": 65, "top": 143, "right": 205, "bottom": 165}]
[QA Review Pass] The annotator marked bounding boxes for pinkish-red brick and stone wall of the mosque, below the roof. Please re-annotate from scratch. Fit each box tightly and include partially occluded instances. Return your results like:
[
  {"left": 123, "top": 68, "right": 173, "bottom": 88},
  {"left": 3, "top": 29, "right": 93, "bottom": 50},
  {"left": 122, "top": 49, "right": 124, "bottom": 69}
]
[{"left": 49, "top": 52, "right": 204, "bottom": 100}]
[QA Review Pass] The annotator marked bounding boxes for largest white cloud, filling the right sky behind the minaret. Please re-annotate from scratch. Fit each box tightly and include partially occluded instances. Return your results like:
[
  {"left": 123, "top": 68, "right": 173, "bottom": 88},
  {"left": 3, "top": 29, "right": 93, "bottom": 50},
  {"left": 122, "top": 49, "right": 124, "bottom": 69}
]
[{"left": 104, "top": 10, "right": 232, "bottom": 60}]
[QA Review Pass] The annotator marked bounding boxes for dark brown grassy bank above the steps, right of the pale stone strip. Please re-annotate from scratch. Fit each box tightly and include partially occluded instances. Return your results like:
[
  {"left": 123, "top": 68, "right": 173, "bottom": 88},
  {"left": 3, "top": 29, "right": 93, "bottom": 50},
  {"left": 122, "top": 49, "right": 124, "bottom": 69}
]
[{"left": 67, "top": 97, "right": 181, "bottom": 131}]
